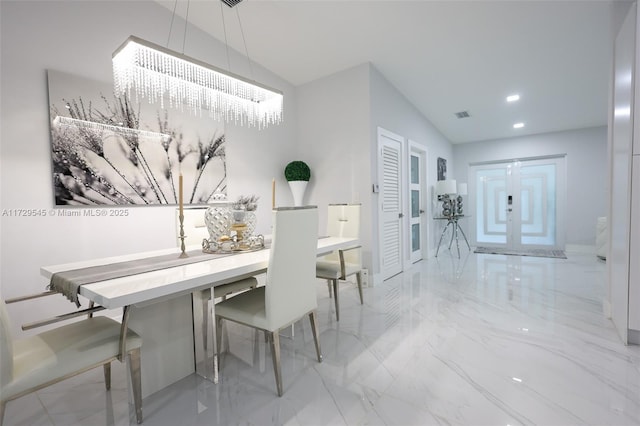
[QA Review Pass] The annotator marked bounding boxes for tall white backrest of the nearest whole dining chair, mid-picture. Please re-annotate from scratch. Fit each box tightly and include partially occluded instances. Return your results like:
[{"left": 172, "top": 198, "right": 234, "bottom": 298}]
[{"left": 265, "top": 206, "right": 318, "bottom": 330}]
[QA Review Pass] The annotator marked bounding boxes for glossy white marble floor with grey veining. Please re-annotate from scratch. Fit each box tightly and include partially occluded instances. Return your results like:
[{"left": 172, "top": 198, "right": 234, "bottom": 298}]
[{"left": 5, "top": 252, "right": 640, "bottom": 426}]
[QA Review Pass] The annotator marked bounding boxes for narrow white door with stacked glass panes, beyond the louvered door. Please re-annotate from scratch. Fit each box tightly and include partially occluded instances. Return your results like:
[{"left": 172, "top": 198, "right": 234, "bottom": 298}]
[{"left": 409, "top": 146, "right": 427, "bottom": 263}]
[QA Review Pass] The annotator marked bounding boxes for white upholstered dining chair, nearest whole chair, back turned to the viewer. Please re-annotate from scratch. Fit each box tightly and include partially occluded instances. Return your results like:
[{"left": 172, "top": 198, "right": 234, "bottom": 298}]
[{"left": 216, "top": 206, "right": 322, "bottom": 396}]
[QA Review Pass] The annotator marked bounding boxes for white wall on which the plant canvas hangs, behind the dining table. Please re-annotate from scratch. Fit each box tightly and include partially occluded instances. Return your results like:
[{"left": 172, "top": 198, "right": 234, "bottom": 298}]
[{"left": 0, "top": 0, "right": 297, "bottom": 333}]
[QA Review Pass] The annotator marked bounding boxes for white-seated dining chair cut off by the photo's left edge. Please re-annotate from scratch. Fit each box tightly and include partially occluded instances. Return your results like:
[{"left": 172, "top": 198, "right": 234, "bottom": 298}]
[{"left": 0, "top": 301, "right": 142, "bottom": 425}]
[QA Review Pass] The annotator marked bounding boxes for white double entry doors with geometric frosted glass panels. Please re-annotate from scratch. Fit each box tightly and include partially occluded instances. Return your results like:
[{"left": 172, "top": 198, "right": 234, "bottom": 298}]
[{"left": 469, "top": 156, "right": 566, "bottom": 249}]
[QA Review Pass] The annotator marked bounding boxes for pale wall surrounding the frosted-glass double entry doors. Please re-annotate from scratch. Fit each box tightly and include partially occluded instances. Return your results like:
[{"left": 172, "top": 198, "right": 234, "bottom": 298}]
[{"left": 453, "top": 126, "right": 609, "bottom": 246}]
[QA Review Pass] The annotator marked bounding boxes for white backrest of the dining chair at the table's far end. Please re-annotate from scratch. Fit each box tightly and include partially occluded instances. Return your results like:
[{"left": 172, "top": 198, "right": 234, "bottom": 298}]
[{"left": 324, "top": 204, "right": 362, "bottom": 265}]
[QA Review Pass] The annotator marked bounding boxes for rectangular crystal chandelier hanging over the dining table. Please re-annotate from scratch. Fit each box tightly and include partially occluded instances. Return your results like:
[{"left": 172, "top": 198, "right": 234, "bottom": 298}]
[{"left": 112, "top": 36, "right": 283, "bottom": 128}]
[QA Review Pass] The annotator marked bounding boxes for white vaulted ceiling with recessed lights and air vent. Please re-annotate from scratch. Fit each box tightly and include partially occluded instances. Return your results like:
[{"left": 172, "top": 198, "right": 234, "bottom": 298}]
[{"left": 157, "top": 0, "right": 626, "bottom": 143}]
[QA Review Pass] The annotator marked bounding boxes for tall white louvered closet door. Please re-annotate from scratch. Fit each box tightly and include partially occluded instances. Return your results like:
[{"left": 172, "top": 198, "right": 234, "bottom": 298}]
[{"left": 378, "top": 129, "right": 402, "bottom": 280}]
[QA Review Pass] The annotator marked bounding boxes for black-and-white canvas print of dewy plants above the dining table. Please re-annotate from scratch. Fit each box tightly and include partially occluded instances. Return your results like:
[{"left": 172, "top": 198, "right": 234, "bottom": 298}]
[{"left": 48, "top": 70, "right": 227, "bottom": 206}]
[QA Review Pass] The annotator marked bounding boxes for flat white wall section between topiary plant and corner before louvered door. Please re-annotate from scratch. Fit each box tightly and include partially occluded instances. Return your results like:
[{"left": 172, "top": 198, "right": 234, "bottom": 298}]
[{"left": 290, "top": 65, "right": 371, "bottom": 268}]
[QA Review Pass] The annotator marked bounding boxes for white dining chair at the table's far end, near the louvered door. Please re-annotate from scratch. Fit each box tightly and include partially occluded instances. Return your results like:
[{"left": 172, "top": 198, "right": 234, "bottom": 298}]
[{"left": 316, "top": 204, "right": 364, "bottom": 321}]
